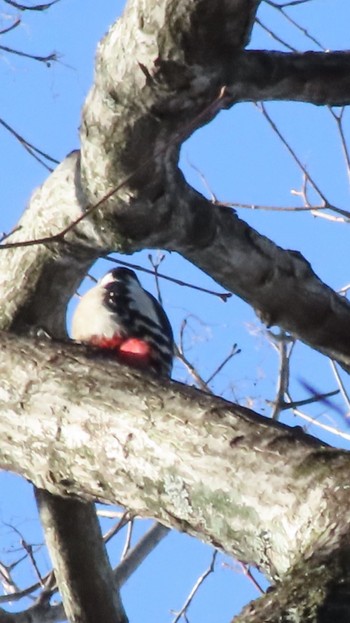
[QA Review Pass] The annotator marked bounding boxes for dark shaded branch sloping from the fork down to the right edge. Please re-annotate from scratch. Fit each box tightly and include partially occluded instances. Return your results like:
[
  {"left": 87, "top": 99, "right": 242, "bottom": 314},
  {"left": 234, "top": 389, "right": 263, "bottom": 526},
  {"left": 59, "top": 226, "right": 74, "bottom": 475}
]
[{"left": 175, "top": 191, "right": 350, "bottom": 370}]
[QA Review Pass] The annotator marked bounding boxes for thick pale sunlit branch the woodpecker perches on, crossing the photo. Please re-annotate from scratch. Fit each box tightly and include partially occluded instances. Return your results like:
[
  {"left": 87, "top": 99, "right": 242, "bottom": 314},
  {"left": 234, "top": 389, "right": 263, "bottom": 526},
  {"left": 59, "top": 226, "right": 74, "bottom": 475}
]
[{"left": 0, "top": 334, "right": 350, "bottom": 577}]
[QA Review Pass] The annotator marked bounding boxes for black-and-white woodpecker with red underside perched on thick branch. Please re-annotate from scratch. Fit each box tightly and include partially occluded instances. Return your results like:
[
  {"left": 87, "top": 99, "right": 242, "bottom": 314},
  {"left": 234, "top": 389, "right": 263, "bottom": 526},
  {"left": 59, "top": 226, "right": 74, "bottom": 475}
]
[{"left": 72, "top": 268, "right": 174, "bottom": 376}]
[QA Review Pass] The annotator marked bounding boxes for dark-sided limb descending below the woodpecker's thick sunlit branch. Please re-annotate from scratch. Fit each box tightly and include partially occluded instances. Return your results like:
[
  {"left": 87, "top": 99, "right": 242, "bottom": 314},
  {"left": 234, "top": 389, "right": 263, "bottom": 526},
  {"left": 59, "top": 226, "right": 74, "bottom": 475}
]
[{"left": 36, "top": 489, "right": 127, "bottom": 623}]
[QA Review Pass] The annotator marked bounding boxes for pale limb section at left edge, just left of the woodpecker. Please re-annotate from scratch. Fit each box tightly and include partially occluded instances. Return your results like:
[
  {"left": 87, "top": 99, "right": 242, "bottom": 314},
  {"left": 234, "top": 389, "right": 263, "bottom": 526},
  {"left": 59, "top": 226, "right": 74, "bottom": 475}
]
[{"left": 0, "top": 152, "right": 95, "bottom": 338}]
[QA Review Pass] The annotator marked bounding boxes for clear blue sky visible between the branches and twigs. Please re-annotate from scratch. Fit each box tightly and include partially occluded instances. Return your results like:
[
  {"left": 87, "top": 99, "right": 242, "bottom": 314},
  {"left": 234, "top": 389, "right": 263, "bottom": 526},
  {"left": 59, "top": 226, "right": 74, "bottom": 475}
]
[{"left": 0, "top": 0, "right": 350, "bottom": 623}]
